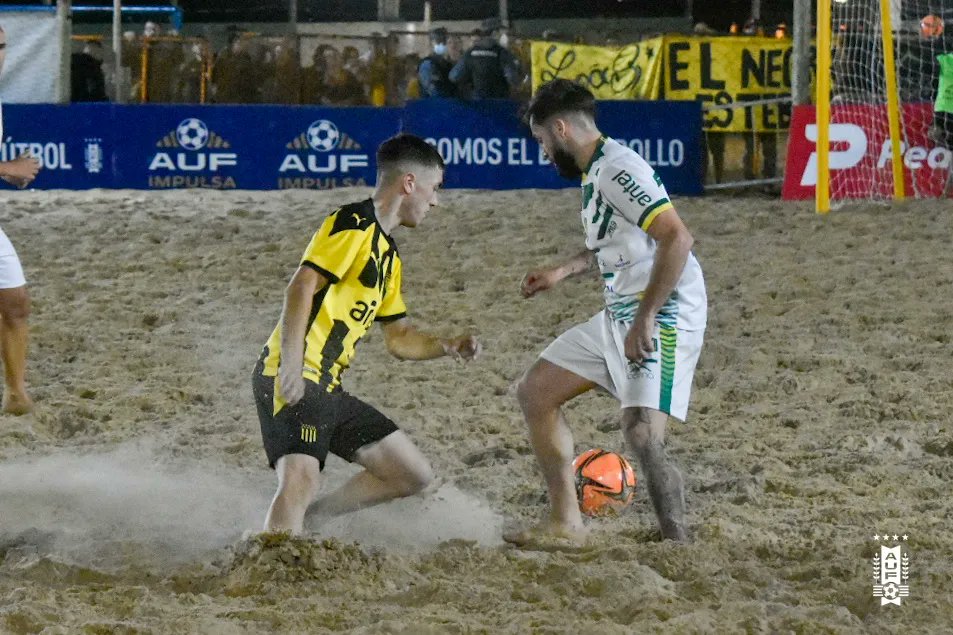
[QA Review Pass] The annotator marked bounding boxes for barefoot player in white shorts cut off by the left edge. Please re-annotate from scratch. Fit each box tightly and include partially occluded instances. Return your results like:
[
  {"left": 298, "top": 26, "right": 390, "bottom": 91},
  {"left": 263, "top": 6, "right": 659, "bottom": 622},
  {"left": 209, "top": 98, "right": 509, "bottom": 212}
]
[{"left": 0, "top": 27, "right": 40, "bottom": 415}]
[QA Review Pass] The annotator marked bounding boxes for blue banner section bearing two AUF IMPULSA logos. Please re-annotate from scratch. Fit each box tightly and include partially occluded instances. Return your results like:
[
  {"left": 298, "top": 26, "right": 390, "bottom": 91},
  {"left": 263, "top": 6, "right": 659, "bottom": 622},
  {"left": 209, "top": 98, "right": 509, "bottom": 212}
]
[{"left": 114, "top": 105, "right": 400, "bottom": 190}]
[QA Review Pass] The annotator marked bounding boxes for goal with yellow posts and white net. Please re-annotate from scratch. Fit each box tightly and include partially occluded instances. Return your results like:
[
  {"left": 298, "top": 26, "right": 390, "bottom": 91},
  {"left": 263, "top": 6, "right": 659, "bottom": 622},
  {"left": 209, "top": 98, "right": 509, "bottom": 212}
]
[{"left": 808, "top": 0, "right": 953, "bottom": 213}]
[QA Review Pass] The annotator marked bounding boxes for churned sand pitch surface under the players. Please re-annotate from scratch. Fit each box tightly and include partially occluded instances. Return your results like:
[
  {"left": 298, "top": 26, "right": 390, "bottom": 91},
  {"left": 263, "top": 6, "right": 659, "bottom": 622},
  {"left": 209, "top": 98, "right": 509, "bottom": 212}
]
[{"left": 0, "top": 189, "right": 953, "bottom": 634}]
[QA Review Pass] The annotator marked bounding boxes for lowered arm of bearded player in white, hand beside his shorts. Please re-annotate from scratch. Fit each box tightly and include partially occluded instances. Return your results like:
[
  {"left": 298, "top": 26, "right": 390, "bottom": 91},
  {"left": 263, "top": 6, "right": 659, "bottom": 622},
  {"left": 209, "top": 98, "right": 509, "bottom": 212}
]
[{"left": 625, "top": 207, "right": 695, "bottom": 363}]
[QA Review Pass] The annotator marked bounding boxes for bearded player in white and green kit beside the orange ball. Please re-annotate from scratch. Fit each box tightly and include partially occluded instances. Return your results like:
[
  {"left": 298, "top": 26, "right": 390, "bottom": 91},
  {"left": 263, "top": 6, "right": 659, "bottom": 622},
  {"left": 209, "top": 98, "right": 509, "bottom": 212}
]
[{"left": 504, "top": 79, "right": 707, "bottom": 544}]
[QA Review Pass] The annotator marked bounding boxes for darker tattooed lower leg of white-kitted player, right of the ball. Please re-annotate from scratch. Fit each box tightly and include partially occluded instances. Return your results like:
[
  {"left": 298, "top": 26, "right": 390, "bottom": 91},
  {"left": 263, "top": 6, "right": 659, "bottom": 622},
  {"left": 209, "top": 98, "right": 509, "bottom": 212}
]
[{"left": 622, "top": 408, "right": 688, "bottom": 542}]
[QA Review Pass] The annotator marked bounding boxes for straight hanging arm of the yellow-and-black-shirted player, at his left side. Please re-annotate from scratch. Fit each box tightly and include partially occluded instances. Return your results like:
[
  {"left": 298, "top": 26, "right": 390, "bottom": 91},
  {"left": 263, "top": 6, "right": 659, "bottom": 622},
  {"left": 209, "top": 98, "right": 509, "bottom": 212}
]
[{"left": 278, "top": 265, "right": 329, "bottom": 404}]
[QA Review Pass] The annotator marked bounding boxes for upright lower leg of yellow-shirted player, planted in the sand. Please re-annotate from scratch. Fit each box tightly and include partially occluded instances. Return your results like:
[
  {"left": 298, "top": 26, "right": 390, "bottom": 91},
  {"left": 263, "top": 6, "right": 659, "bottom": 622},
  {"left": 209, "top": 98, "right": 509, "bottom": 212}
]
[{"left": 265, "top": 454, "right": 321, "bottom": 534}]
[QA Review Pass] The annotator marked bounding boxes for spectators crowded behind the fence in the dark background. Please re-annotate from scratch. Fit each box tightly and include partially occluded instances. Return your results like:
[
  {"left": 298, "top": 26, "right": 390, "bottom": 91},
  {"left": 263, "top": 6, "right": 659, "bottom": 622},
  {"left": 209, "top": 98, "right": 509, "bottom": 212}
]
[{"left": 72, "top": 18, "right": 951, "bottom": 189}]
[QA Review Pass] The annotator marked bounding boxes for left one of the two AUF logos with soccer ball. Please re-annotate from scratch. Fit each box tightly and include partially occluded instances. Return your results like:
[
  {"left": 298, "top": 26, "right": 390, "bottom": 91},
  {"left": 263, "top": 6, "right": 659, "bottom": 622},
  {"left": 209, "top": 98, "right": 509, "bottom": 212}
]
[{"left": 149, "top": 117, "right": 238, "bottom": 172}]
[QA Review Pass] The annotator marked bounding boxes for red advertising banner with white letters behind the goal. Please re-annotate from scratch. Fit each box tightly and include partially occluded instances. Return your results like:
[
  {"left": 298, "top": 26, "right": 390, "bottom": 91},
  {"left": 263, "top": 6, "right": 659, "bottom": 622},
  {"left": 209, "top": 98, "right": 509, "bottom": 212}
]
[{"left": 782, "top": 103, "right": 953, "bottom": 200}]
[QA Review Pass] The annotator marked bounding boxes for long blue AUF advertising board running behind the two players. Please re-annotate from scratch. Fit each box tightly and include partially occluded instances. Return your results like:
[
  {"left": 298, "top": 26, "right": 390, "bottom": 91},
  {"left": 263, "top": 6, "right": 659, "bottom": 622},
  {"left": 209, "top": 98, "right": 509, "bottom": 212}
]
[{"left": 0, "top": 100, "right": 702, "bottom": 194}]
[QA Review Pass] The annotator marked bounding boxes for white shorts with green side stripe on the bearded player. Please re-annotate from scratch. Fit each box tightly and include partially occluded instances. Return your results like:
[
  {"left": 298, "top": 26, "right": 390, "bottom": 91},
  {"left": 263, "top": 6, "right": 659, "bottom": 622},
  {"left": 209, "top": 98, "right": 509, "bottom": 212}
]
[{"left": 540, "top": 311, "right": 705, "bottom": 421}]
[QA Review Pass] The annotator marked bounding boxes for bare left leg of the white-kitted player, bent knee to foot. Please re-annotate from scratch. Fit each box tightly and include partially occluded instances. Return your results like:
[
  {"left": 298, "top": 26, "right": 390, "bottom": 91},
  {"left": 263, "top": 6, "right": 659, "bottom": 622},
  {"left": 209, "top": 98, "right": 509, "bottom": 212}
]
[{"left": 503, "top": 359, "right": 596, "bottom": 545}]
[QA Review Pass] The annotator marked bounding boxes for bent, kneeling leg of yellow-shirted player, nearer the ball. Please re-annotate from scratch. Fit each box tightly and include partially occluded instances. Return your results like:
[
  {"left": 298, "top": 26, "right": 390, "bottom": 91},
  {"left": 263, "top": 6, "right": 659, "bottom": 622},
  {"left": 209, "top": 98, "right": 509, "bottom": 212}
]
[{"left": 313, "top": 430, "right": 434, "bottom": 524}]
